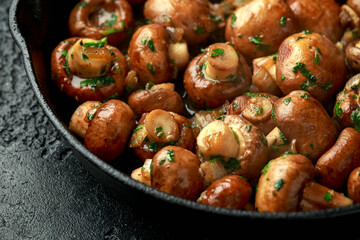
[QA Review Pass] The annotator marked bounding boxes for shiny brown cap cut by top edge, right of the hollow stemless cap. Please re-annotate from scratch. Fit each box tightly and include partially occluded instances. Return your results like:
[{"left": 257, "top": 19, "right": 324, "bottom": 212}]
[{"left": 144, "top": 0, "right": 216, "bottom": 45}]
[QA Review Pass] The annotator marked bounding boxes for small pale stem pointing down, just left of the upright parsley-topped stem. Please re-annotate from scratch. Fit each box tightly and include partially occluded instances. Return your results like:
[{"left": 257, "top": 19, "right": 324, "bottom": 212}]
[{"left": 168, "top": 42, "right": 190, "bottom": 70}]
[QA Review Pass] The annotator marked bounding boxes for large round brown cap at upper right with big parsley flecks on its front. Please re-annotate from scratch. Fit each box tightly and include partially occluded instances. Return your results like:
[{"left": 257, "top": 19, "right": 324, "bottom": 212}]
[{"left": 276, "top": 31, "right": 347, "bottom": 103}]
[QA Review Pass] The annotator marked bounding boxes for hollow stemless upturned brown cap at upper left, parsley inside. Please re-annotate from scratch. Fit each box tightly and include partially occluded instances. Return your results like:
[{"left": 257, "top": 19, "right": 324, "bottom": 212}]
[{"left": 69, "top": 0, "right": 134, "bottom": 46}]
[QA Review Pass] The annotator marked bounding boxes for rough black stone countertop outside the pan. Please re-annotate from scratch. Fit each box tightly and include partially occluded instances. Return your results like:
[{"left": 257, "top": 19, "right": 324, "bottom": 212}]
[{"left": 0, "top": 0, "right": 359, "bottom": 240}]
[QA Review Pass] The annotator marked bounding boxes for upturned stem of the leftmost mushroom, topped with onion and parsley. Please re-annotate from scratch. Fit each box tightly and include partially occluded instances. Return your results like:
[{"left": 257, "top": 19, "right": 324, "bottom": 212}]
[{"left": 67, "top": 38, "right": 113, "bottom": 78}]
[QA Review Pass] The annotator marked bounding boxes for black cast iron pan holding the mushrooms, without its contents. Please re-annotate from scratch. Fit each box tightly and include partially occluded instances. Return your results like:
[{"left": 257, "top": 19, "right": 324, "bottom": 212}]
[{"left": 9, "top": 0, "right": 360, "bottom": 227}]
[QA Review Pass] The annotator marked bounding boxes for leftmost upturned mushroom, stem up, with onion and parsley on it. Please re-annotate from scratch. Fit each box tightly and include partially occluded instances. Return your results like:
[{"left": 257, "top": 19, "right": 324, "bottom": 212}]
[{"left": 51, "top": 38, "right": 128, "bottom": 102}]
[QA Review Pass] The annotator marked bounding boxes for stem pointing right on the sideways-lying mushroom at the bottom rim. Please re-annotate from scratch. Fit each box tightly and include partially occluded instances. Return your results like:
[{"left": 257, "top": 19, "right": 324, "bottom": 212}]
[{"left": 300, "top": 181, "right": 353, "bottom": 211}]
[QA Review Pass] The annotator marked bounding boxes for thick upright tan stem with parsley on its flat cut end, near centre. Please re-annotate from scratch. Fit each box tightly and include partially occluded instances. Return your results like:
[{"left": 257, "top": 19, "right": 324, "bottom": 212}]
[{"left": 205, "top": 43, "right": 239, "bottom": 81}]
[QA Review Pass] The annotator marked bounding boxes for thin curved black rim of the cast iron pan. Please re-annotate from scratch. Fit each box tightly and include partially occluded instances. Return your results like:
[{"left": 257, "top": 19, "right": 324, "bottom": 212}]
[{"left": 8, "top": 0, "right": 360, "bottom": 220}]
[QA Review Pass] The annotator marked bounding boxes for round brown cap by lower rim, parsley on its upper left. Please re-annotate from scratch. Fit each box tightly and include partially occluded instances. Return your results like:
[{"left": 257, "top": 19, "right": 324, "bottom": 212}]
[{"left": 151, "top": 146, "right": 203, "bottom": 200}]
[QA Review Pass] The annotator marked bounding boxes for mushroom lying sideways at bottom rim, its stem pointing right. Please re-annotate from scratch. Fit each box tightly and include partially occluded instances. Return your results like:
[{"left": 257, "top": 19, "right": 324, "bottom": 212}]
[{"left": 255, "top": 154, "right": 353, "bottom": 212}]
